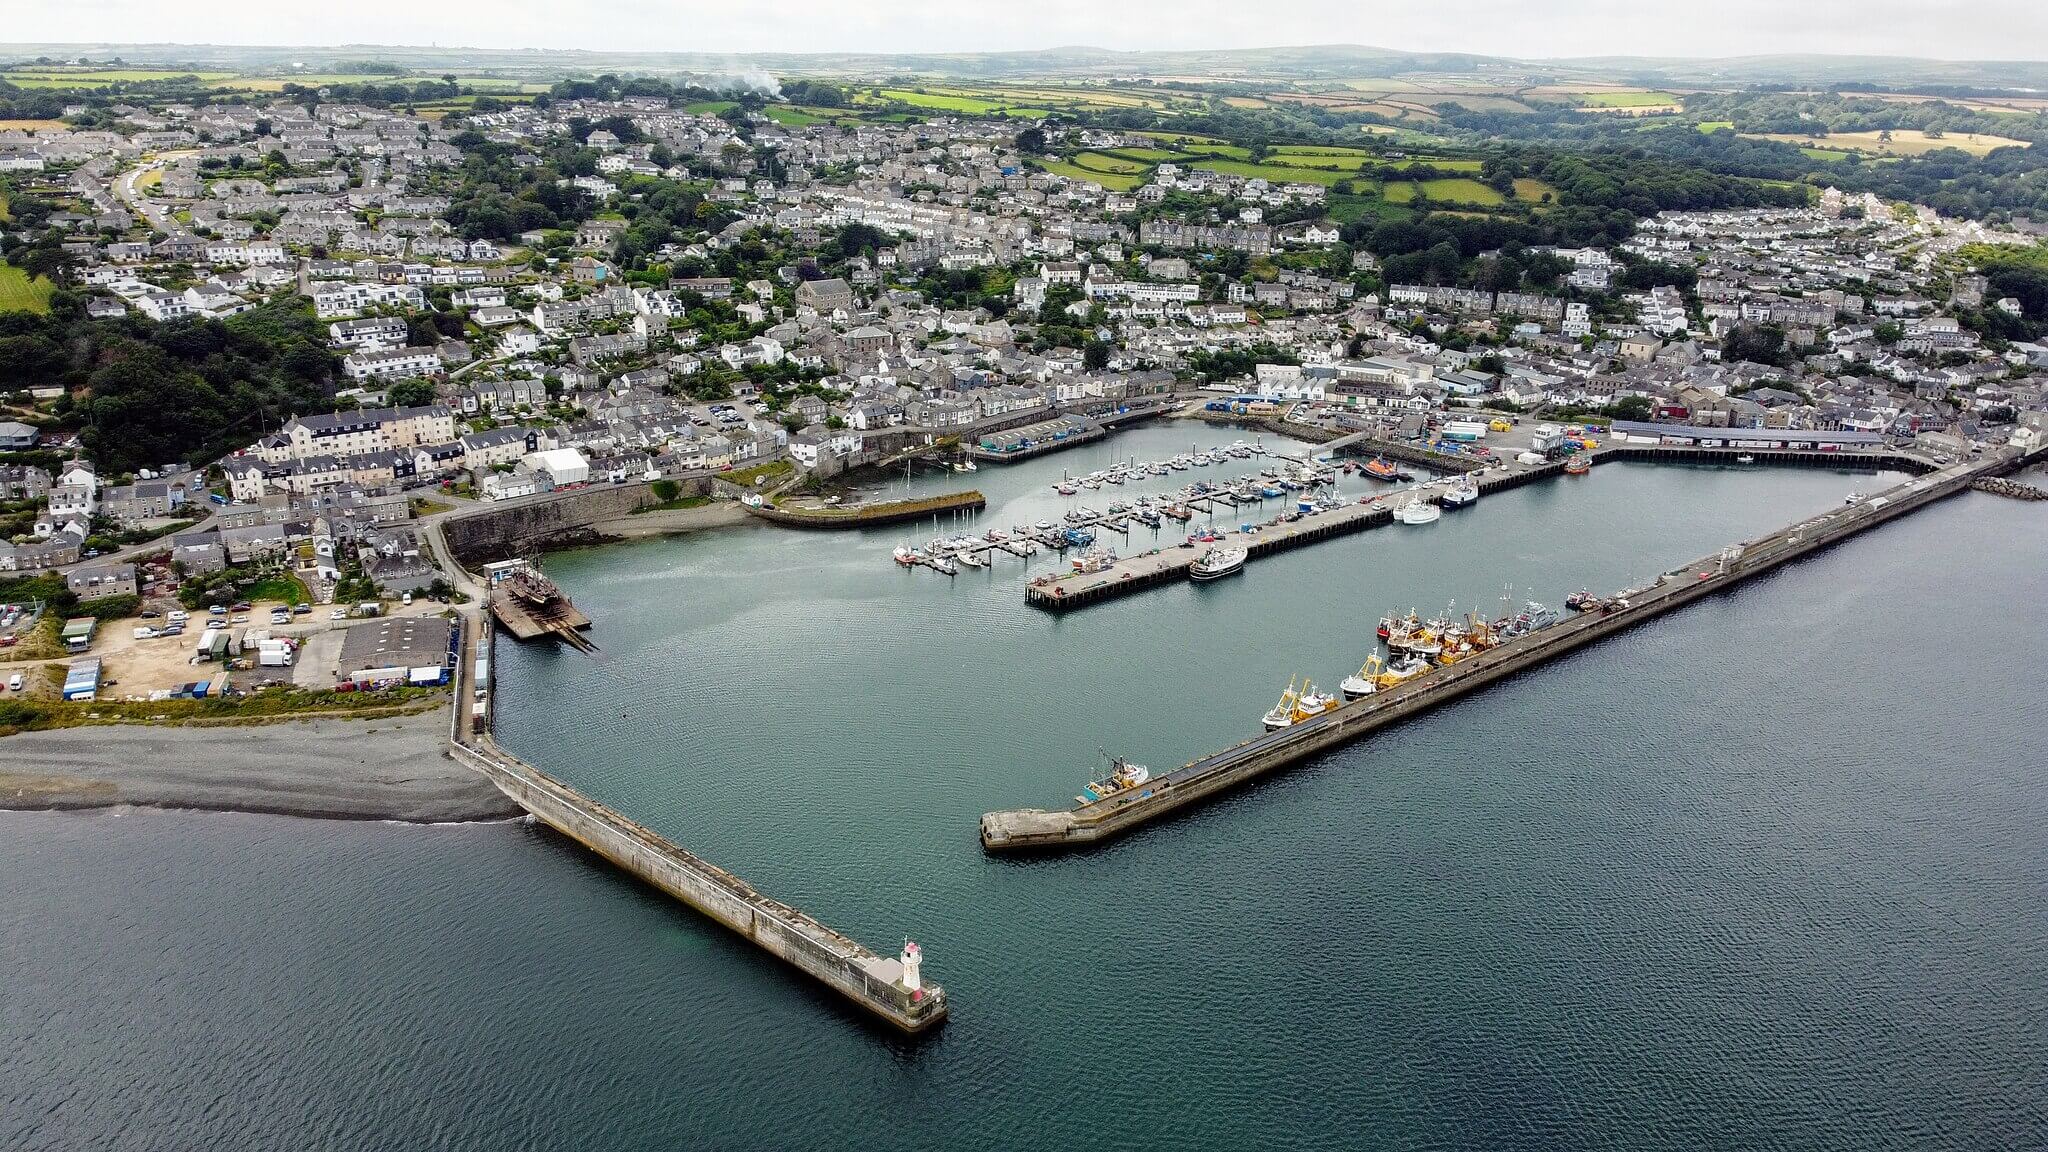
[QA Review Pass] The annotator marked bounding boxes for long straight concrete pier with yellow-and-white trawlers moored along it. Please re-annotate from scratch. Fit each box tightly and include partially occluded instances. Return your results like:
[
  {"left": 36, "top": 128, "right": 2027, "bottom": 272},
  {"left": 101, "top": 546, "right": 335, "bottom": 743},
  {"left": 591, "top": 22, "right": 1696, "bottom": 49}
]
[{"left": 981, "top": 455, "right": 2021, "bottom": 853}]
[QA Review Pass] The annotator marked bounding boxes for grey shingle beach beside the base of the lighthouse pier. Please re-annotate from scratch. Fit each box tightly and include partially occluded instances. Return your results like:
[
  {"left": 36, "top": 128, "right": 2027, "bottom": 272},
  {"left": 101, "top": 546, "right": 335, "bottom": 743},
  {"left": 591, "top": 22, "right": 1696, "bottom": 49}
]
[{"left": 0, "top": 709, "right": 524, "bottom": 824}]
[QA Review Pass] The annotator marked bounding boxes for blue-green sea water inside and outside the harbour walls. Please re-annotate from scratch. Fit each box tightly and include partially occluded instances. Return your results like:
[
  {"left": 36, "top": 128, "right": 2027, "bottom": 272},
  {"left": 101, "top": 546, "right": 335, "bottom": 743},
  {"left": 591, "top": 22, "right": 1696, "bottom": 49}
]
[{"left": 0, "top": 424, "right": 2048, "bottom": 1150}]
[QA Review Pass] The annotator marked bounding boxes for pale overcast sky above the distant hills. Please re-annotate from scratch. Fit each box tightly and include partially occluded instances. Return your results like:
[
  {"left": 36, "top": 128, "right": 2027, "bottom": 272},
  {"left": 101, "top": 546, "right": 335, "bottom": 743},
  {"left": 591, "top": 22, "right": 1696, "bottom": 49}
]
[{"left": 12, "top": 0, "right": 2048, "bottom": 59}]
